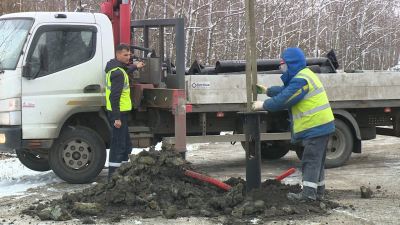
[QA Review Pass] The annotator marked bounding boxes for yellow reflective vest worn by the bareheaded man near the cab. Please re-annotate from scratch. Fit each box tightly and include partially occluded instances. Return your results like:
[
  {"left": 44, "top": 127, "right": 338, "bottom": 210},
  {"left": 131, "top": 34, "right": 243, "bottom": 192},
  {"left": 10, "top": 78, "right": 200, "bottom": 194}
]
[{"left": 106, "top": 67, "right": 132, "bottom": 111}]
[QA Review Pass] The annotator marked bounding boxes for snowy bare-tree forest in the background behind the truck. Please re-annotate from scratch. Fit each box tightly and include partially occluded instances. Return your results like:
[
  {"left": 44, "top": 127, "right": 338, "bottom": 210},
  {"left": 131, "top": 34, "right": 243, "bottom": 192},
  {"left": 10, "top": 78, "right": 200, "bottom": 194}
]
[{"left": 0, "top": 0, "right": 400, "bottom": 70}]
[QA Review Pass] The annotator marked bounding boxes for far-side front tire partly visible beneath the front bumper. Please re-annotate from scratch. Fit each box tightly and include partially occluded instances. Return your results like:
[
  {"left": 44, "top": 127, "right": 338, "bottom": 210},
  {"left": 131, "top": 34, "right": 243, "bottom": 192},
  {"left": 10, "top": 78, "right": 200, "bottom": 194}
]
[{"left": 16, "top": 150, "right": 51, "bottom": 172}]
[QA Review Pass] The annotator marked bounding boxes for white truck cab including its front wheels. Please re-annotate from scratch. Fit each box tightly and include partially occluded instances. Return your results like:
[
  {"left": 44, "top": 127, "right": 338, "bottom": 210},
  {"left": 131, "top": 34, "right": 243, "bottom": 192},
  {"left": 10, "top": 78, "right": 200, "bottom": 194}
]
[{"left": 0, "top": 12, "right": 114, "bottom": 183}]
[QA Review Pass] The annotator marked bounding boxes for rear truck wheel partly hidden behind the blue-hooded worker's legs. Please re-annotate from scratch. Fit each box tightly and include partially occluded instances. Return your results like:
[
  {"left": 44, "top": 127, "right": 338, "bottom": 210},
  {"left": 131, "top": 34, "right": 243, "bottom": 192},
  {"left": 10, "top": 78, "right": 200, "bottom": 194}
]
[{"left": 296, "top": 119, "right": 354, "bottom": 169}]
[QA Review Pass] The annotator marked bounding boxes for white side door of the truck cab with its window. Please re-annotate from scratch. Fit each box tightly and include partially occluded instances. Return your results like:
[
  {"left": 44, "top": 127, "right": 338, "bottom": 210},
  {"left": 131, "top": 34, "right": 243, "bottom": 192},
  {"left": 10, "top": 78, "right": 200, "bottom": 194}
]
[{"left": 21, "top": 24, "right": 105, "bottom": 139}]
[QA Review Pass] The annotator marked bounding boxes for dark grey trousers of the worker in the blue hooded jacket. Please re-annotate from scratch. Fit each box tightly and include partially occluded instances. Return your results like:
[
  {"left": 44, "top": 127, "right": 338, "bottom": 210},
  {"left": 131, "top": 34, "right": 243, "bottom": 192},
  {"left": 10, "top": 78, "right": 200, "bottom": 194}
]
[{"left": 301, "top": 134, "right": 330, "bottom": 200}]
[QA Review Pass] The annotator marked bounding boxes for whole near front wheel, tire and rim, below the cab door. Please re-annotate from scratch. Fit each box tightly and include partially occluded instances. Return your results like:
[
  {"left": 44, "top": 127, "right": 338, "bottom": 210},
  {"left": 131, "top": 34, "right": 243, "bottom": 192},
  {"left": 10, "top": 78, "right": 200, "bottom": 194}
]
[{"left": 49, "top": 126, "right": 107, "bottom": 184}]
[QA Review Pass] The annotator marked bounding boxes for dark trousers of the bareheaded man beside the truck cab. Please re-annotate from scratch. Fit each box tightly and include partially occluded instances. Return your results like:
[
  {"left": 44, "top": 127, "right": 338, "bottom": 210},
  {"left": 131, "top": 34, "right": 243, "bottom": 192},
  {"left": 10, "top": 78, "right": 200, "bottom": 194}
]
[{"left": 107, "top": 112, "right": 132, "bottom": 179}]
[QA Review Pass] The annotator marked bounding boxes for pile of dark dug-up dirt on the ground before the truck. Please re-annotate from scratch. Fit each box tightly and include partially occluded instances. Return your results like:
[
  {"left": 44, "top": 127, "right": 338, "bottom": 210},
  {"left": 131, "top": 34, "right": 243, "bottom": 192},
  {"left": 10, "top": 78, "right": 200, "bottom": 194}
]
[{"left": 25, "top": 147, "right": 338, "bottom": 224}]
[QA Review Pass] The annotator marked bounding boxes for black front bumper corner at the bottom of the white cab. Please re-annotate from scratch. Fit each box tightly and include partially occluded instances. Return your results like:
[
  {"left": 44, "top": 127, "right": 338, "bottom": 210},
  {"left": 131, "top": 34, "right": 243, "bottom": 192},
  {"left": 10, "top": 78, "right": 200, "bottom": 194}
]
[{"left": 0, "top": 126, "right": 22, "bottom": 152}]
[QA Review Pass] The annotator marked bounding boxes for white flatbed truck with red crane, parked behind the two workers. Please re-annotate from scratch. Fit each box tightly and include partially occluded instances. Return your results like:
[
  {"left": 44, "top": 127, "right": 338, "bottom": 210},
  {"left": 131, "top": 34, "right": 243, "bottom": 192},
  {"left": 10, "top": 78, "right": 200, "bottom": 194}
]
[{"left": 0, "top": 0, "right": 400, "bottom": 183}]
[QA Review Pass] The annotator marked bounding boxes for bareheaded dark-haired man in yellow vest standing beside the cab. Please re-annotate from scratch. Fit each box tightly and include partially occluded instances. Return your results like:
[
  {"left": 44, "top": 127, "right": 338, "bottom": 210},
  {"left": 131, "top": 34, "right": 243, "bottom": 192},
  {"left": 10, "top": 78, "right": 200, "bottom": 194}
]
[{"left": 105, "top": 44, "right": 146, "bottom": 179}]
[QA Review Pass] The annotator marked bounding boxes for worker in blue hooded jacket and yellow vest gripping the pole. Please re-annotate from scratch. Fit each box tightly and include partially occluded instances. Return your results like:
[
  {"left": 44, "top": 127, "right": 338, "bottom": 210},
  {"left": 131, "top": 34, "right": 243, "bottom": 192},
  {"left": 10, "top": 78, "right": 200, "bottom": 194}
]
[{"left": 252, "top": 47, "right": 335, "bottom": 202}]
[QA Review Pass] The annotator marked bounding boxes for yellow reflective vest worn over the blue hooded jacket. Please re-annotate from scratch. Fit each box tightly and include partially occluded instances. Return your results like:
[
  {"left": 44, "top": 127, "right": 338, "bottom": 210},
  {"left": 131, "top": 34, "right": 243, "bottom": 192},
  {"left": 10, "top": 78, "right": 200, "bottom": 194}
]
[{"left": 291, "top": 68, "right": 334, "bottom": 133}]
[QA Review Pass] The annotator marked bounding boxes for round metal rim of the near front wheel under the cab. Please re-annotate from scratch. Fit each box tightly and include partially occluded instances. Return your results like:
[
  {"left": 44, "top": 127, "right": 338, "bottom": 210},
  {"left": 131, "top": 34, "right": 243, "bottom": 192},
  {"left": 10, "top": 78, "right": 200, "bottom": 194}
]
[{"left": 60, "top": 139, "right": 93, "bottom": 170}]
